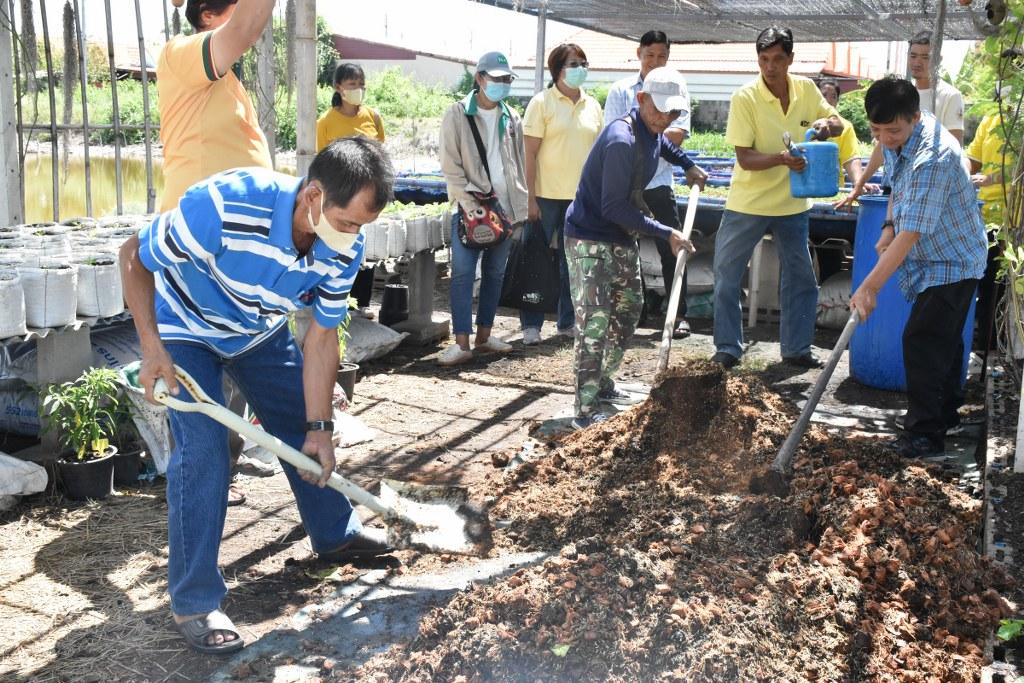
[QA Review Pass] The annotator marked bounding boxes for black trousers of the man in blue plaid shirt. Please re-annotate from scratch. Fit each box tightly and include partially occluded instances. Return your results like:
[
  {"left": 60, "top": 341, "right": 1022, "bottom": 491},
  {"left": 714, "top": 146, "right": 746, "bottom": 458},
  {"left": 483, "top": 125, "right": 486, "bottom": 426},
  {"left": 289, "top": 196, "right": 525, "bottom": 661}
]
[{"left": 903, "top": 280, "right": 978, "bottom": 445}]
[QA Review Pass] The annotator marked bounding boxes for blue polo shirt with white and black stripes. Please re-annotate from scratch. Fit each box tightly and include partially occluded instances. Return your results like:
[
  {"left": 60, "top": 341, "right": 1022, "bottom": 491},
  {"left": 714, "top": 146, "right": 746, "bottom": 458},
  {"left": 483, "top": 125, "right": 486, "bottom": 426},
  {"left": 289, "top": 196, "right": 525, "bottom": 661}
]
[{"left": 139, "top": 168, "right": 364, "bottom": 356}]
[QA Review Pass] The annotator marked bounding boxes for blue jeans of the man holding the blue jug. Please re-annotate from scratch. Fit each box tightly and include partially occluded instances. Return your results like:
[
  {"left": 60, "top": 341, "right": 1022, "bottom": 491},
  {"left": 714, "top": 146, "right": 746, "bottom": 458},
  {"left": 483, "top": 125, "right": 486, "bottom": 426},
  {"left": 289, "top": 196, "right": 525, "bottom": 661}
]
[{"left": 715, "top": 210, "right": 818, "bottom": 358}]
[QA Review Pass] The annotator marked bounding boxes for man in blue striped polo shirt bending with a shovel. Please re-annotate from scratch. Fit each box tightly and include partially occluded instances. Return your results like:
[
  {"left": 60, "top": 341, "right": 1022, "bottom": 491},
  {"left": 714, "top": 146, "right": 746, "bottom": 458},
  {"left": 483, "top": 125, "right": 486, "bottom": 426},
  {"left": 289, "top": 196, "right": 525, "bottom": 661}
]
[{"left": 121, "top": 138, "right": 394, "bottom": 652}]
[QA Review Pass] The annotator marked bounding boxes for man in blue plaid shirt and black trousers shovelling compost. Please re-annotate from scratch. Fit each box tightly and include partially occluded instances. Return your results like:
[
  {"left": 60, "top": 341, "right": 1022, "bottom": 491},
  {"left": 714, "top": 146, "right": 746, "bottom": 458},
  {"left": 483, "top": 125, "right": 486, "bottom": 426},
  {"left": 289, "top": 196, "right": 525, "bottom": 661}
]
[{"left": 850, "top": 76, "right": 988, "bottom": 458}]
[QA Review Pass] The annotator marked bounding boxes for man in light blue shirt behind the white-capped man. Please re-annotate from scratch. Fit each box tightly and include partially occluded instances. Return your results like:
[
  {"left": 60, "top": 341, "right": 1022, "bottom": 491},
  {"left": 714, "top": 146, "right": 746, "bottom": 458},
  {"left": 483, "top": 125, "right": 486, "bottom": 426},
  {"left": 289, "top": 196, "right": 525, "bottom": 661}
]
[{"left": 604, "top": 31, "right": 702, "bottom": 339}]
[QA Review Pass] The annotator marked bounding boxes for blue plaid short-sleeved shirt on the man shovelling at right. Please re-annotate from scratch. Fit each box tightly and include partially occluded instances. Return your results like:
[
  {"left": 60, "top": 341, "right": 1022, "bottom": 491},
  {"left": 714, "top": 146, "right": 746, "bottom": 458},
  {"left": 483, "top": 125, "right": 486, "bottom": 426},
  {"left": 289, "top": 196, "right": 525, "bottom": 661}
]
[{"left": 885, "top": 112, "right": 988, "bottom": 300}]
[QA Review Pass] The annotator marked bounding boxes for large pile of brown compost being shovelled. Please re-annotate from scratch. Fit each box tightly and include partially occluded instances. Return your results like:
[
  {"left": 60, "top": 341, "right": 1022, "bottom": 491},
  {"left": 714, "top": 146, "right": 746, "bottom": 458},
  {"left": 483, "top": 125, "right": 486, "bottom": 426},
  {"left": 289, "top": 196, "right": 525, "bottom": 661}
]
[{"left": 342, "top": 362, "right": 1009, "bottom": 682}]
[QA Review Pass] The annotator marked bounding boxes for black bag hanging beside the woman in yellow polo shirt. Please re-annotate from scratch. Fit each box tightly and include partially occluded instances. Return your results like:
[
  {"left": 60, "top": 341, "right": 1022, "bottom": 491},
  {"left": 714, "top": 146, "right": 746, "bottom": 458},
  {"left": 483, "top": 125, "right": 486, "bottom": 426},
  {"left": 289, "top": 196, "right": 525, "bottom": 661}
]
[{"left": 499, "top": 222, "right": 561, "bottom": 313}]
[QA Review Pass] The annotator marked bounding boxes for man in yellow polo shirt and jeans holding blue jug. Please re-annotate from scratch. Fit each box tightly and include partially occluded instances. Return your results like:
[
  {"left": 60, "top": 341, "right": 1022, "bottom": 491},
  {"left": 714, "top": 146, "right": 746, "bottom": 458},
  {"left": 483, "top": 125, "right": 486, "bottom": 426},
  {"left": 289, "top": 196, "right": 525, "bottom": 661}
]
[{"left": 712, "top": 27, "right": 843, "bottom": 368}]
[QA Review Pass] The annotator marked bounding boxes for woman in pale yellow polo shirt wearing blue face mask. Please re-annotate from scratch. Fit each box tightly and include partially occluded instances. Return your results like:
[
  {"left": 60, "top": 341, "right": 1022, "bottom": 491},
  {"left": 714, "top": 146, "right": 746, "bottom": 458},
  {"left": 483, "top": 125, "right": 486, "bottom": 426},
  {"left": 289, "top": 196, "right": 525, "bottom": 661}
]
[{"left": 519, "top": 43, "right": 604, "bottom": 346}]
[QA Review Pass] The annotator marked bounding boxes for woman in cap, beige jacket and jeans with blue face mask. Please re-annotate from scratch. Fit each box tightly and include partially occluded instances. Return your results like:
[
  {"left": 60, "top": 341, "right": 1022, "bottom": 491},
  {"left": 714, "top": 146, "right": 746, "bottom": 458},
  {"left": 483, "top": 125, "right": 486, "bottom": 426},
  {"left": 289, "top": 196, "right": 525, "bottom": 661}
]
[{"left": 437, "top": 52, "right": 527, "bottom": 366}]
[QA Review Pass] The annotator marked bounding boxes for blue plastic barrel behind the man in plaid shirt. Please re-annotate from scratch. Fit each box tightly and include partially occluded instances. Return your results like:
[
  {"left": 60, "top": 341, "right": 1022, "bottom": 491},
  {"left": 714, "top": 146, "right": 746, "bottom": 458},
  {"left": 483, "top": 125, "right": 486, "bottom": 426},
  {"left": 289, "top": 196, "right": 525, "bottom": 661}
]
[{"left": 850, "top": 197, "right": 974, "bottom": 391}]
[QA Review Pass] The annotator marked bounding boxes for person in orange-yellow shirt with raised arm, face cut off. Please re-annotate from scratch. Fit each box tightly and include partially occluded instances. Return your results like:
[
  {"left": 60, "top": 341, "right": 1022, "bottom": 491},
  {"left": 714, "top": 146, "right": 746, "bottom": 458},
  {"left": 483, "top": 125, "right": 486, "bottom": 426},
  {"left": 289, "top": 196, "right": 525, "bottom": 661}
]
[{"left": 157, "top": 0, "right": 274, "bottom": 211}]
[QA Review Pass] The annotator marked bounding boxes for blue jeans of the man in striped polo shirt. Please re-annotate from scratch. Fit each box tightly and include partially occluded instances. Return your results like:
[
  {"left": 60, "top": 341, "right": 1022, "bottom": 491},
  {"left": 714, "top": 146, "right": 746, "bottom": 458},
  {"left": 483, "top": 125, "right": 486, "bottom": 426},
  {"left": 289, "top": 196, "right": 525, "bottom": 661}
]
[{"left": 167, "top": 327, "right": 361, "bottom": 615}]
